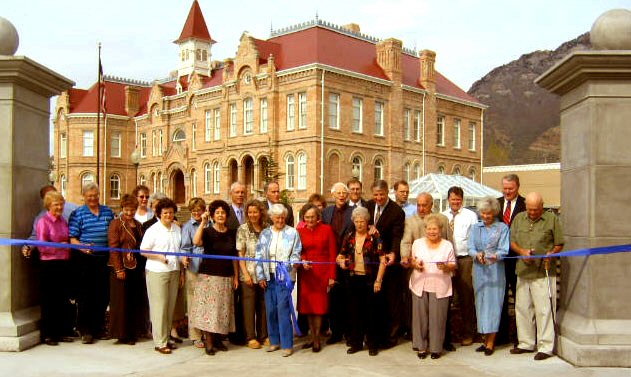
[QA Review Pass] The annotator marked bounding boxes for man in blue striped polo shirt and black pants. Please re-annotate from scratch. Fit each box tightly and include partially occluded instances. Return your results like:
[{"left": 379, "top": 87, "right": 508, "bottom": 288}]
[{"left": 68, "top": 183, "right": 114, "bottom": 344}]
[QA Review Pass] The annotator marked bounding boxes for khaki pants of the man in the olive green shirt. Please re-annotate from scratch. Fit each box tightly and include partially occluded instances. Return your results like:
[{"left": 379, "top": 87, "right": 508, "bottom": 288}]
[{"left": 515, "top": 276, "right": 556, "bottom": 355}]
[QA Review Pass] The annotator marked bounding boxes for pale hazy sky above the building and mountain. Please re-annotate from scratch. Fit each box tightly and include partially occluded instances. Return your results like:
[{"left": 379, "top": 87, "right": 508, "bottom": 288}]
[{"left": 0, "top": 0, "right": 631, "bottom": 91}]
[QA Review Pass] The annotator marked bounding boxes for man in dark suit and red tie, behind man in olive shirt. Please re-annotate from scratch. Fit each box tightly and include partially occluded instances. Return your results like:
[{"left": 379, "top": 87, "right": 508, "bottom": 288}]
[{"left": 495, "top": 174, "right": 526, "bottom": 345}]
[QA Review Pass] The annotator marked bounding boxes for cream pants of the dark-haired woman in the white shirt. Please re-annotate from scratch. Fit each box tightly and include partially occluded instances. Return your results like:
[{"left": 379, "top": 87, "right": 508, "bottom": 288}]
[{"left": 147, "top": 271, "right": 180, "bottom": 347}]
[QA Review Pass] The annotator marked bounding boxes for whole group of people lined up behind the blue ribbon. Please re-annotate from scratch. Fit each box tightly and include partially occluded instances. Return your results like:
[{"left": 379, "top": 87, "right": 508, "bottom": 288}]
[{"left": 23, "top": 174, "right": 563, "bottom": 360}]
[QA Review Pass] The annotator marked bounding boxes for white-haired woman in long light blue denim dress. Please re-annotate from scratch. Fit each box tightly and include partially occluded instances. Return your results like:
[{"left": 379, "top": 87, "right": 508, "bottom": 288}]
[{"left": 469, "top": 196, "right": 510, "bottom": 356}]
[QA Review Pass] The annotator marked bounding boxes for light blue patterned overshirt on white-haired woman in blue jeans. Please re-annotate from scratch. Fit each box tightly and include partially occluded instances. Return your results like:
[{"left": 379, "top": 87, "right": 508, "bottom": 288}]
[{"left": 256, "top": 225, "right": 302, "bottom": 281}]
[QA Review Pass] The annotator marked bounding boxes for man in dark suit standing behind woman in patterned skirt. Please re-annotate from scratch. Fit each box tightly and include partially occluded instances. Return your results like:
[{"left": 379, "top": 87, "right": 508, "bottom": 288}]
[{"left": 226, "top": 182, "right": 246, "bottom": 345}]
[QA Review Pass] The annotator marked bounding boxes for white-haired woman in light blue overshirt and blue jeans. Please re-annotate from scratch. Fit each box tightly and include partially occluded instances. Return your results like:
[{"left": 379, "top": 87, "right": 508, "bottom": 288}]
[{"left": 256, "top": 204, "right": 302, "bottom": 357}]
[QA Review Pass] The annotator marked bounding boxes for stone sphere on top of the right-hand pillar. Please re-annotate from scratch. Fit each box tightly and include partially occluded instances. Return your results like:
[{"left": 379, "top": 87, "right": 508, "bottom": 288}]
[{"left": 589, "top": 9, "right": 631, "bottom": 50}]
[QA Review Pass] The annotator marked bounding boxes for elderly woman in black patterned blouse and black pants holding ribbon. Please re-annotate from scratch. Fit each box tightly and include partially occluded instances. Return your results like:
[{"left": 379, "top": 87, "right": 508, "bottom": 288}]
[{"left": 337, "top": 207, "right": 386, "bottom": 356}]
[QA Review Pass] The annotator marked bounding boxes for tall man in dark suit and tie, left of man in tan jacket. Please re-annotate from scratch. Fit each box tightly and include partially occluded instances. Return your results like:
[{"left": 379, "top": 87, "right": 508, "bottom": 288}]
[{"left": 366, "top": 180, "right": 408, "bottom": 355}]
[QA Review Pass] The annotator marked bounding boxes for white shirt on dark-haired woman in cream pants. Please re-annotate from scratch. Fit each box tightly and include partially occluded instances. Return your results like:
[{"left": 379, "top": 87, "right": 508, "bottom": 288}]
[{"left": 140, "top": 221, "right": 182, "bottom": 272}]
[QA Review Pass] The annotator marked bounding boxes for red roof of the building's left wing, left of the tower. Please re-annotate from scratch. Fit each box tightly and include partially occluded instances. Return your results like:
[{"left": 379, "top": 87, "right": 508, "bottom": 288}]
[{"left": 68, "top": 79, "right": 151, "bottom": 116}]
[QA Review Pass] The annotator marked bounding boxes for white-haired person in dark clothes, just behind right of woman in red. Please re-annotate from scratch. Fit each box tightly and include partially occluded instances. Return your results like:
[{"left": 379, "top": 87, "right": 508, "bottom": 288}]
[{"left": 322, "top": 182, "right": 353, "bottom": 344}]
